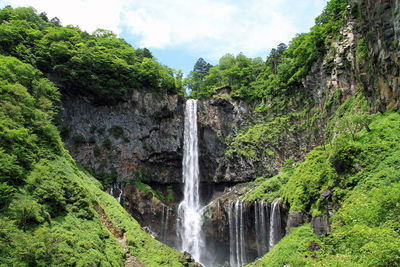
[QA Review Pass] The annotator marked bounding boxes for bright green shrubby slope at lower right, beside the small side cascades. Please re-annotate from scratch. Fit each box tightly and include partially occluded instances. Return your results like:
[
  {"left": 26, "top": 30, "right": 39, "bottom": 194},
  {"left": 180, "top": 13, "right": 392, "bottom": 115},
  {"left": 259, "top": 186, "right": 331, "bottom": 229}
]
[{"left": 245, "top": 108, "right": 400, "bottom": 266}]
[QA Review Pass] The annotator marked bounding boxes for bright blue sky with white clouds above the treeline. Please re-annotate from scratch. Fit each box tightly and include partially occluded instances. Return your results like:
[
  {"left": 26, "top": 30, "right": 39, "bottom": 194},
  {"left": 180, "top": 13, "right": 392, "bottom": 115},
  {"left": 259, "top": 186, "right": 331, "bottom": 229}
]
[{"left": 0, "top": 0, "right": 327, "bottom": 74}]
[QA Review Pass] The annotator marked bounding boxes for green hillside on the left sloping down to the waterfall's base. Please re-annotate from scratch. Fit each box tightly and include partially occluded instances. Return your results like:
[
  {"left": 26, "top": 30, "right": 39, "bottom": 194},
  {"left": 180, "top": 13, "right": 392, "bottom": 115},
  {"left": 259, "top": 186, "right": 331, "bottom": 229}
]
[{"left": 0, "top": 20, "right": 188, "bottom": 266}]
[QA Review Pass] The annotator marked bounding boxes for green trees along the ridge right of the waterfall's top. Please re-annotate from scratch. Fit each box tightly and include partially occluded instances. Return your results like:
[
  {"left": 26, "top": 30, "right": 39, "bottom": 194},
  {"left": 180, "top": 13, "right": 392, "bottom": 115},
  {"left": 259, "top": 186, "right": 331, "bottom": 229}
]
[{"left": 184, "top": 0, "right": 347, "bottom": 101}]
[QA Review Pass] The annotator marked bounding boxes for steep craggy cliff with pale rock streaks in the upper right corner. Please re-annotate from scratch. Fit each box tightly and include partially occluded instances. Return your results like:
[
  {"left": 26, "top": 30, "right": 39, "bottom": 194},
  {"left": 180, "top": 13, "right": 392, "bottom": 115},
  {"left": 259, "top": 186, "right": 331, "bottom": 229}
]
[{"left": 303, "top": 0, "right": 400, "bottom": 111}]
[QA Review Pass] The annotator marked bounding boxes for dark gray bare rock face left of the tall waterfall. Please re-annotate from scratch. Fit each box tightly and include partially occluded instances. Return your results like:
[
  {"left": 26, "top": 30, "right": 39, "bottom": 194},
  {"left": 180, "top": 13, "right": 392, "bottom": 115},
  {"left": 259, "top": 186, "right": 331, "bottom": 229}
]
[{"left": 61, "top": 91, "right": 184, "bottom": 183}]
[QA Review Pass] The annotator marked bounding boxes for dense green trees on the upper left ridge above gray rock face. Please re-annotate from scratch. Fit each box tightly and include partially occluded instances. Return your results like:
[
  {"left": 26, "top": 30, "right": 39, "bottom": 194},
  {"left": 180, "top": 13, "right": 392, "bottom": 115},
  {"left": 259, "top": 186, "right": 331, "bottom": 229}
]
[{"left": 0, "top": 7, "right": 183, "bottom": 104}]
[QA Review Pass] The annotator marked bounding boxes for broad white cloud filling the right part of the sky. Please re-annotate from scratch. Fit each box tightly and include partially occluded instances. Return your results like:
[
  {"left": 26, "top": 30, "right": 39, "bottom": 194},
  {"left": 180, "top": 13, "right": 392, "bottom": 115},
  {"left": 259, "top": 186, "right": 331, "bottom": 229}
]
[{"left": 121, "top": 0, "right": 324, "bottom": 59}]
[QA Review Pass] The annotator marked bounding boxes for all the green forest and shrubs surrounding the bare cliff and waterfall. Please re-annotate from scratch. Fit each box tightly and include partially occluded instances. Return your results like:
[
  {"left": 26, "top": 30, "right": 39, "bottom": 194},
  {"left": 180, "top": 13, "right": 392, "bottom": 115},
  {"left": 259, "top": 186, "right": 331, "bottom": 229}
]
[{"left": 0, "top": 0, "right": 400, "bottom": 266}]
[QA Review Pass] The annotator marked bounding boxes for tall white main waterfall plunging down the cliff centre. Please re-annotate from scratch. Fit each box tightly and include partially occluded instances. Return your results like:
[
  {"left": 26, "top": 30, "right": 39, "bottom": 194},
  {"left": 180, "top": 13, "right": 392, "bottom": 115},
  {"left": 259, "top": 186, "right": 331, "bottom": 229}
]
[{"left": 177, "top": 99, "right": 204, "bottom": 261}]
